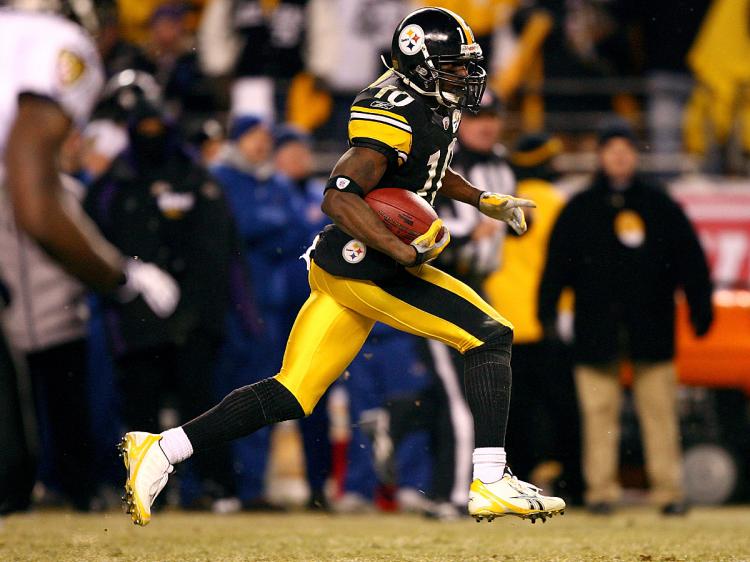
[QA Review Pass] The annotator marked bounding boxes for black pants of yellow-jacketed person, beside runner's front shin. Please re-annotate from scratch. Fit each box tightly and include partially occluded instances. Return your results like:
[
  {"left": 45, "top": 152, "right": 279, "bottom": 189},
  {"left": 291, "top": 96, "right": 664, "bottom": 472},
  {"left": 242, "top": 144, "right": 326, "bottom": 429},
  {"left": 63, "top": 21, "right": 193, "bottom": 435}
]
[{"left": 506, "top": 342, "right": 582, "bottom": 500}]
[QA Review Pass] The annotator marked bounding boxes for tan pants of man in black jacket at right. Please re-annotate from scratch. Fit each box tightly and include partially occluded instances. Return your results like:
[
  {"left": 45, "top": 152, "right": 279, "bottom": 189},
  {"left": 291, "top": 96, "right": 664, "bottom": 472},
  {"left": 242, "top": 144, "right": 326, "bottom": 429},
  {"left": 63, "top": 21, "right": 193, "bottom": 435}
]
[{"left": 575, "top": 361, "right": 682, "bottom": 505}]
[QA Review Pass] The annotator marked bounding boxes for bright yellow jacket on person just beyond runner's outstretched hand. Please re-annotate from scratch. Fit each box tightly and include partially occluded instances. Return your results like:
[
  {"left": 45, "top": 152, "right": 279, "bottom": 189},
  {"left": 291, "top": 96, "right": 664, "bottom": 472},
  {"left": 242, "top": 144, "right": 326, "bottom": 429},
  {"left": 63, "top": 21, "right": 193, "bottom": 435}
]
[{"left": 484, "top": 179, "right": 565, "bottom": 343}]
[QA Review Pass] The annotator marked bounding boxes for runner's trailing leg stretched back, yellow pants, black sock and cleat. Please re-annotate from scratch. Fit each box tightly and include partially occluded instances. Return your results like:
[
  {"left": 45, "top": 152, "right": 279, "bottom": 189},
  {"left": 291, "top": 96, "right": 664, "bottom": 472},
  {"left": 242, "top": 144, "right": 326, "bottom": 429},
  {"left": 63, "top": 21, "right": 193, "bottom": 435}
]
[{"left": 121, "top": 285, "right": 374, "bottom": 525}]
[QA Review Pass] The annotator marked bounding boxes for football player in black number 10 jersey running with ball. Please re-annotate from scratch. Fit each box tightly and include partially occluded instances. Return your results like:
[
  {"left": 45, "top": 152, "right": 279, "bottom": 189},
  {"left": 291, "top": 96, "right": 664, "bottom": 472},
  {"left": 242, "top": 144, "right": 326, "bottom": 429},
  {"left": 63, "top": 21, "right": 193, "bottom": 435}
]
[{"left": 121, "top": 8, "right": 565, "bottom": 525}]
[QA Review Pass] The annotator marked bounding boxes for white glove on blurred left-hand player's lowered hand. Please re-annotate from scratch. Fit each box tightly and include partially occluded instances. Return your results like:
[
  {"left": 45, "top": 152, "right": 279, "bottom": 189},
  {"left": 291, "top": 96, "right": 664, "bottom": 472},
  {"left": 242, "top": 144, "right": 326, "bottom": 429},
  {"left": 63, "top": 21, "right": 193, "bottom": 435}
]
[{"left": 117, "top": 259, "right": 180, "bottom": 318}]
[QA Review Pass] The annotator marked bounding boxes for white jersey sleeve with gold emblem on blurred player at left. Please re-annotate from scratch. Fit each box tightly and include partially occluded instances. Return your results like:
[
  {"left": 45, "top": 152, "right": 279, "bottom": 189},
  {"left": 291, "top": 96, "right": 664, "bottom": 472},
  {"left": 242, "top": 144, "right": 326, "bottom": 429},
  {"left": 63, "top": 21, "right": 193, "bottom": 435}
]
[{"left": 0, "top": 9, "right": 104, "bottom": 161}]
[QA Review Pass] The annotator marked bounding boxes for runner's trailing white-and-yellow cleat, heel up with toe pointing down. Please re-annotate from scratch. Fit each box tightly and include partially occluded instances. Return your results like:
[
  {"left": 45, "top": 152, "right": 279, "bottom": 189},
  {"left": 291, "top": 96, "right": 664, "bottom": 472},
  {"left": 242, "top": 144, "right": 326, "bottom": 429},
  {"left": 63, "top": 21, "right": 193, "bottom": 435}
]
[{"left": 117, "top": 431, "right": 174, "bottom": 526}]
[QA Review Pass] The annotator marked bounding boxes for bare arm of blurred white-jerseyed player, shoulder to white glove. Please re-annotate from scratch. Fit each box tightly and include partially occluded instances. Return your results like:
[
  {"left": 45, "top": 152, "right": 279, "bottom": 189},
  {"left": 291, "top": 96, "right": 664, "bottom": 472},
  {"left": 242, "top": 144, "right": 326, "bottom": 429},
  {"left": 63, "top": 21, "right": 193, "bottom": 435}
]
[{"left": 5, "top": 95, "right": 125, "bottom": 292}]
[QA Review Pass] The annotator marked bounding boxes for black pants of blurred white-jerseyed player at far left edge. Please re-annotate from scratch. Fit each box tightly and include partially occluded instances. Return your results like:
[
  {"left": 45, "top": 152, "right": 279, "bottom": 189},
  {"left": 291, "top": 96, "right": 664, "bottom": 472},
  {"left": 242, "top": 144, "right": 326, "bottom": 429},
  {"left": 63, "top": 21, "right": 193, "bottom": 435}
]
[{"left": 0, "top": 331, "right": 36, "bottom": 515}]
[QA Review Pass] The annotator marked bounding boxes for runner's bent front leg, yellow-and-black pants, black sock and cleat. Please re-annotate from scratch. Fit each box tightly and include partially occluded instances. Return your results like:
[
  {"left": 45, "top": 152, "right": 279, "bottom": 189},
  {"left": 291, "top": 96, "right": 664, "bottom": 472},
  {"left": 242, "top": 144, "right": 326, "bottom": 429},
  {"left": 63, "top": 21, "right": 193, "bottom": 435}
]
[{"left": 310, "top": 264, "right": 565, "bottom": 520}]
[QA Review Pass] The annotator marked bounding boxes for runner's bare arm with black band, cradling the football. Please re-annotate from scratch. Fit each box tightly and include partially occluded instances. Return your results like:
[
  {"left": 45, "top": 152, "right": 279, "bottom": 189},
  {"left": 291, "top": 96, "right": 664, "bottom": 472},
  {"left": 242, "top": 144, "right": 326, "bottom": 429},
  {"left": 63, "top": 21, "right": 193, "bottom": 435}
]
[{"left": 321, "top": 146, "right": 416, "bottom": 265}]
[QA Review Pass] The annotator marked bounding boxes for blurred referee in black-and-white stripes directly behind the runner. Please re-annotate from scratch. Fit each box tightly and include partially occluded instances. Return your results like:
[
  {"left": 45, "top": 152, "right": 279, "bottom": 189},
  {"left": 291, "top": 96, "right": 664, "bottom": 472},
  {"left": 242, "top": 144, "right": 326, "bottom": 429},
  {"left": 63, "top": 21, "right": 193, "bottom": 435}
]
[{"left": 419, "top": 90, "right": 515, "bottom": 519}]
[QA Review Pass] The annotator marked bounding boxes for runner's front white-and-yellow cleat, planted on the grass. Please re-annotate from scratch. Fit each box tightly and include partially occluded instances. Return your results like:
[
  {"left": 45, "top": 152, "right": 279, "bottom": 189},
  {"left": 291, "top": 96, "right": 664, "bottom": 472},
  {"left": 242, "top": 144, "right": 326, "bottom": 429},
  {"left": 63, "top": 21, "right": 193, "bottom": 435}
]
[{"left": 469, "top": 471, "right": 565, "bottom": 523}]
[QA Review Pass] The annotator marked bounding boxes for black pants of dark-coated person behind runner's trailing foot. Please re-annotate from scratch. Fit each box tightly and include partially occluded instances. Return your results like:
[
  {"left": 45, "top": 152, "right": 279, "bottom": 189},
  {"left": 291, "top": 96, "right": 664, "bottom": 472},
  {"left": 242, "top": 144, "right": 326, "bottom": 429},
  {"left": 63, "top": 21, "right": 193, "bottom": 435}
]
[{"left": 116, "top": 334, "right": 235, "bottom": 497}]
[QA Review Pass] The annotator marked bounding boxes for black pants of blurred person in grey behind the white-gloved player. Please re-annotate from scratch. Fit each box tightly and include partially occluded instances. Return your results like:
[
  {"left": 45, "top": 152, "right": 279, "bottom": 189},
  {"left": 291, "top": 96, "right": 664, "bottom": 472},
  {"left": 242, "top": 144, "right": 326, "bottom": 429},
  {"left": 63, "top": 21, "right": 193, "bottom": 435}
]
[{"left": 26, "top": 339, "right": 96, "bottom": 510}]
